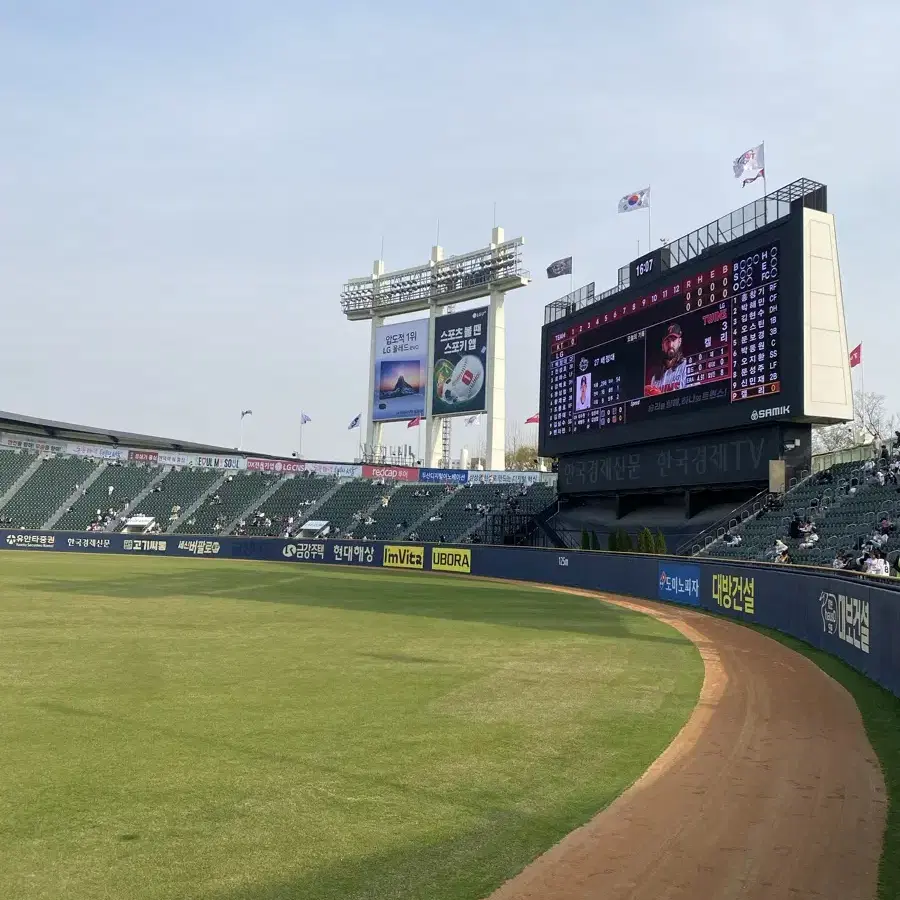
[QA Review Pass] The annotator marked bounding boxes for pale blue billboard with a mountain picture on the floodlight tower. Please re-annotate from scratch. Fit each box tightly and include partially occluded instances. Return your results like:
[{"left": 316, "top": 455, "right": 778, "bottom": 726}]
[{"left": 372, "top": 319, "right": 428, "bottom": 422}]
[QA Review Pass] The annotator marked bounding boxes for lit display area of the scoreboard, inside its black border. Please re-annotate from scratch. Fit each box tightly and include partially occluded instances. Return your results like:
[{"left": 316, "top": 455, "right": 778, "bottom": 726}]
[{"left": 545, "top": 240, "right": 781, "bottom": 440}]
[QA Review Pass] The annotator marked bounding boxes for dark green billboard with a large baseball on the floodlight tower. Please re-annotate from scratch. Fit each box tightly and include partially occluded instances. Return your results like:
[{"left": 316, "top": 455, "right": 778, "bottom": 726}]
[{"left": 431, "top": 306, "right": 488, "bottom": 416}]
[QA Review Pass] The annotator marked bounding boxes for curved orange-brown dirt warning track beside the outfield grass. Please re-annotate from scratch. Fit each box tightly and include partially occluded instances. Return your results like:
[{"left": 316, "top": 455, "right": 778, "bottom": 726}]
[{"left": 491, "top": 591, "right": 887, "bottom": 900}]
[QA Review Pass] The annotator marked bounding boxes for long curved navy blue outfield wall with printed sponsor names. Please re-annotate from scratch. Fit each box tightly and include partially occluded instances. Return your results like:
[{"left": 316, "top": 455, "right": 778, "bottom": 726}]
[{"left": 0, "top": 530, "right": 900, "bottom": 696}]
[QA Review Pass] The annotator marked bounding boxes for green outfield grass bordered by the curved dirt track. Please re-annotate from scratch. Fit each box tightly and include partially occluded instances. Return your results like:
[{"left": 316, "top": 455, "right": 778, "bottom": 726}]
[{"left": 0, "top": 552, "right": 703, "bottom": 900}]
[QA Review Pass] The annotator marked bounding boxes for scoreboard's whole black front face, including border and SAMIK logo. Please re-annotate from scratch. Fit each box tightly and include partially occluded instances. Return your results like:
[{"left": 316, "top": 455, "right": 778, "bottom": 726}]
[{"left": 541, "top": 221, "right": 802, "bottom": 456}]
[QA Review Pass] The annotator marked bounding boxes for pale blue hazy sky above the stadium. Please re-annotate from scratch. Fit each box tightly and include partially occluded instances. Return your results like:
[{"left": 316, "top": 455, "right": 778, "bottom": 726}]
[{"left": 0, "top": 0, "right": 900, "bottom": 459}]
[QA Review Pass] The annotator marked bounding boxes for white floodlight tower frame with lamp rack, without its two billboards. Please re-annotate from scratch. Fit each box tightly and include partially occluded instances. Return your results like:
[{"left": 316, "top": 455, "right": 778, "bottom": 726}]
[{"left": 341, "top": 227, "right": 531, "bottom": 470}]
